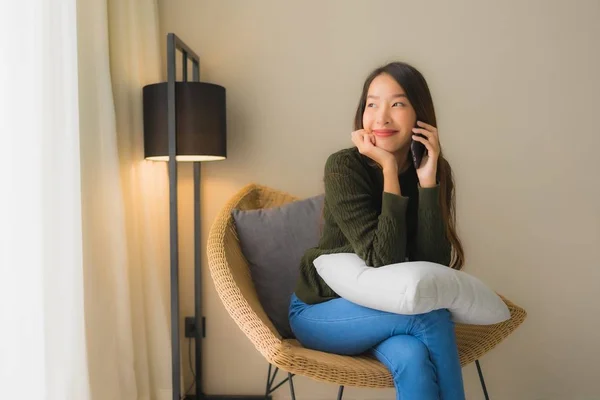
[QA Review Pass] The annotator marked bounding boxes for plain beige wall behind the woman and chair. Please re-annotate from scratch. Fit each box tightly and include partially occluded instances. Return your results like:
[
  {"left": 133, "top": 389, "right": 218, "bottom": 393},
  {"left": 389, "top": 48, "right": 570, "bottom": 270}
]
[{"left": 159, "top": 0, "right": 600, "bottom": 400}]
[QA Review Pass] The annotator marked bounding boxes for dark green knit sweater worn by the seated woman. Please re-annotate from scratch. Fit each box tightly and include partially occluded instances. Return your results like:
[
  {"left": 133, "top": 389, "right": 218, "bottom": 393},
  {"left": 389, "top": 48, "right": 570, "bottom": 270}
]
[{"left": 295, "top": 147, "right": 451, "bottom": 304}]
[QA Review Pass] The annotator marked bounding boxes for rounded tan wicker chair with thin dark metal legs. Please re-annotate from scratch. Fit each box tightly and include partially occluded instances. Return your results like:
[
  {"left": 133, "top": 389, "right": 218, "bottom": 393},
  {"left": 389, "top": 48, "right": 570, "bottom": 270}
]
[{"left": 208, "top": 184, "right": 527, "bottom": 399}]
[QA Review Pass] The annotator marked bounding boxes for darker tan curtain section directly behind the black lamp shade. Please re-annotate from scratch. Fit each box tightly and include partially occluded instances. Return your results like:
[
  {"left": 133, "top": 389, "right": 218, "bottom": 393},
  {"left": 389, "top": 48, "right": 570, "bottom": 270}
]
[{"left": 108, "top": 0, "right": 172, "bottom": 400}]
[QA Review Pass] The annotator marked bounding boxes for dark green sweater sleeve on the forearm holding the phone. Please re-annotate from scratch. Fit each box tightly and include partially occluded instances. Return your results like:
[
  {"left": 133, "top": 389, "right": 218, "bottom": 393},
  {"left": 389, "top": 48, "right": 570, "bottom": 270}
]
[{"left": 411, "top": 185, "right": 451, "bottom": 266}]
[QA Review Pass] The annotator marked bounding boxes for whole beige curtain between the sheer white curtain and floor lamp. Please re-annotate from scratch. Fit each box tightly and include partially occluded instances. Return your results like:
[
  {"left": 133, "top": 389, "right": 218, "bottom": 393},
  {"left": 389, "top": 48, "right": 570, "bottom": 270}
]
[{"left": 78, "top": 0, "right": 171, "bottom": 400}]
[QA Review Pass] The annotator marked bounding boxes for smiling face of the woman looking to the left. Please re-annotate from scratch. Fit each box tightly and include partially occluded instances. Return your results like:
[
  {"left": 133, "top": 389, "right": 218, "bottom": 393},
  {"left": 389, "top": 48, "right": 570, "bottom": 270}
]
[{"left": 363, "top": 73, "right": 416, "bottom": 153}]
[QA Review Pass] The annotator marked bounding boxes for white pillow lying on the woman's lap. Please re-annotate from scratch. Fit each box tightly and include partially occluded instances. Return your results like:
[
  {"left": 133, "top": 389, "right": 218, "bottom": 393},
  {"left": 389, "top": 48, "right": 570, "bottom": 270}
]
[{"left": 314, "top": 253, "right": 510, "bottom": 325}]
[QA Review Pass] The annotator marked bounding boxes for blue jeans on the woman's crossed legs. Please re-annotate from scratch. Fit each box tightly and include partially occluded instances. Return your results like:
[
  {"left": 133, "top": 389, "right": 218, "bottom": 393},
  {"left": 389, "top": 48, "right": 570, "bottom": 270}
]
[{"left": 289, "top": 294, "right": 465, "bottom": 400}]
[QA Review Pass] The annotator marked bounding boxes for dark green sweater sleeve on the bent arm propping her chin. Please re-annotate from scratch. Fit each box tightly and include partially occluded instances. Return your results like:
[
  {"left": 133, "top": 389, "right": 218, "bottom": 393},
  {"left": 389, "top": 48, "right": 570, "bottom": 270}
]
[{"left": 324, "top": 152, "right": 408, "bottom": 267}]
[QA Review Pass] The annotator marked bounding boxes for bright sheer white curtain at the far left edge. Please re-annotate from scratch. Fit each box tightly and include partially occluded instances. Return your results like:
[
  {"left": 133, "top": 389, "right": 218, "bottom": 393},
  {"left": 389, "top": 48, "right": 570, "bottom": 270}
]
[{"left": 0, "top": 0, "right": 89, "bottom": 400}]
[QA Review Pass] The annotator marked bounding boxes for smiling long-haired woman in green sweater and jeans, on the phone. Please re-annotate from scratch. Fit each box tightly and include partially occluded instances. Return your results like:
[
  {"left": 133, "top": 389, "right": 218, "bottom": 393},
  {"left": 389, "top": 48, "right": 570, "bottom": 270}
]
[{"left": 289, "top": 62, "right": 465, "bottom": 400}]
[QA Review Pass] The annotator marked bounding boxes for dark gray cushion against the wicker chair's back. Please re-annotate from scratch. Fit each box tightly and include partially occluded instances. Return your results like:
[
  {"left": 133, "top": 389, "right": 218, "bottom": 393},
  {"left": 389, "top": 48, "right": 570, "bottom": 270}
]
[{"left": 232, "top": 195, "right": 324, "bottom": 338}]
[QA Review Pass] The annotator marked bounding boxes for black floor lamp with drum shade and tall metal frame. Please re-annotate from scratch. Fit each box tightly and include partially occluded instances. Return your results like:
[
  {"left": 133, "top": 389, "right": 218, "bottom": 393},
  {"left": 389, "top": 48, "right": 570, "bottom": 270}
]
[{"left": 143, "top": 33, "right": 264, "bottom": 400}]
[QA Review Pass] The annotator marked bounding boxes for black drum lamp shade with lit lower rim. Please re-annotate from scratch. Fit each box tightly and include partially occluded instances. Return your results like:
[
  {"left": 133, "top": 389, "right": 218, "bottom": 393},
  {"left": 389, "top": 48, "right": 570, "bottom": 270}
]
[{"left": 143, "top": 82, "right": 227, "bottom": 161}]
